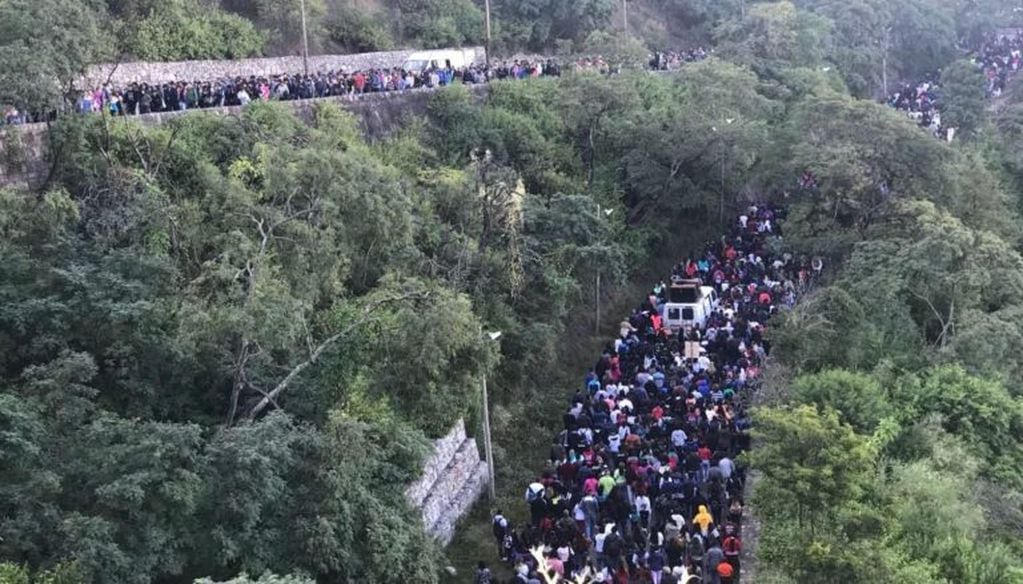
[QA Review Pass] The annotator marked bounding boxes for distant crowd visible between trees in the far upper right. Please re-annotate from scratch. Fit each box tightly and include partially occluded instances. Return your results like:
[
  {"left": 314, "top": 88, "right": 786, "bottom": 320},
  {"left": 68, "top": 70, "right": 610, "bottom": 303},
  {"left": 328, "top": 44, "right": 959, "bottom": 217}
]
[{"left": 888, "top": 32, "right": 1023, "bottom": 140}]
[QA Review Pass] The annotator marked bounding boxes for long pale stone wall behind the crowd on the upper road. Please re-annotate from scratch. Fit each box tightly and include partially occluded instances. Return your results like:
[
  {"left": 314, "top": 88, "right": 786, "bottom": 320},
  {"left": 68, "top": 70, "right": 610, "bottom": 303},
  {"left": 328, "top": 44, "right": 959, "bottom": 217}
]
[{"left": 82, "top": 47, "right": 484, "bottom": 87}]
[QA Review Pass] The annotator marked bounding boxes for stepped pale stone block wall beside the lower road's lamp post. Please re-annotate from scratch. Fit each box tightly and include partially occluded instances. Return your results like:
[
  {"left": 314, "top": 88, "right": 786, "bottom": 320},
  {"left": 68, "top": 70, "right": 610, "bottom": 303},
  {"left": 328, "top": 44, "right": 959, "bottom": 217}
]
[{"left": 405, "top": 420, "right": 488, "bottom": 545}]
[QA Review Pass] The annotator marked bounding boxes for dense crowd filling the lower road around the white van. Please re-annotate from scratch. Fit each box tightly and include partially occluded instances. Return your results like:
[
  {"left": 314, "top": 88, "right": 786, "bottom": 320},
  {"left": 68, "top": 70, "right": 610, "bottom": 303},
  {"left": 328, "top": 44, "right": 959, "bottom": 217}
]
[{"left": 476, "top": 206, "right": 820, "bottom": 584}]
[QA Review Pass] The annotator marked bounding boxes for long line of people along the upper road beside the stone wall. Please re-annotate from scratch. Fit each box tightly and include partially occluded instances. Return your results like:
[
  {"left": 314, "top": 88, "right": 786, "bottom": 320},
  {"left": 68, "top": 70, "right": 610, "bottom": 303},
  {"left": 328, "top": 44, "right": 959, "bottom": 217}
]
[{"left": 0, "top": 49, "right": 707, "bottom": 124}]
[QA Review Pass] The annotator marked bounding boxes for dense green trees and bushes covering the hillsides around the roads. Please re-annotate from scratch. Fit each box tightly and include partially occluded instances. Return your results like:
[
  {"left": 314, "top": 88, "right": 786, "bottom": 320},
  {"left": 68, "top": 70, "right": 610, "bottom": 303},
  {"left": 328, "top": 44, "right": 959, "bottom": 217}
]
[{"left": 0, "top": 0, "right": 1023, "bottom": 584}]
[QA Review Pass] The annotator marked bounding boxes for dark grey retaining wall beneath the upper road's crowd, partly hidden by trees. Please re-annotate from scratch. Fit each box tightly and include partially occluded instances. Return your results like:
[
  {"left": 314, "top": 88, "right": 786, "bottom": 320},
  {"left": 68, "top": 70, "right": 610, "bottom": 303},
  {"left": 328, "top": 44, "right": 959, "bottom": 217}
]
[{"left": 0, "top": 85, "right": 487, "bottom": 189}]
